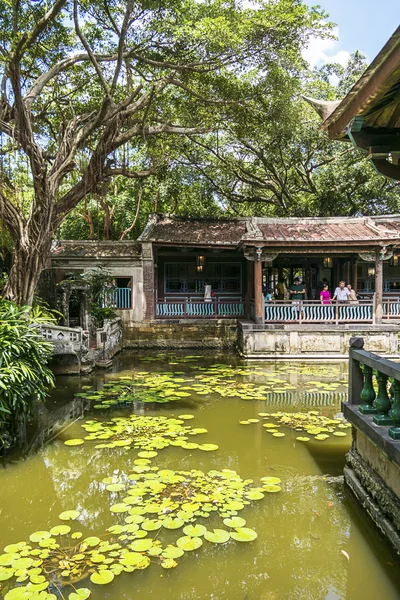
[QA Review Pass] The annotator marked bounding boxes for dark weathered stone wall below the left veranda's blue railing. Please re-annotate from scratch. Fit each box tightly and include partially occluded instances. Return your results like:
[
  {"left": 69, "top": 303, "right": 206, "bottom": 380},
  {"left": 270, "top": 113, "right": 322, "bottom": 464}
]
[{"left": 123, "top": 319, "right": 237, "bottom": 349}]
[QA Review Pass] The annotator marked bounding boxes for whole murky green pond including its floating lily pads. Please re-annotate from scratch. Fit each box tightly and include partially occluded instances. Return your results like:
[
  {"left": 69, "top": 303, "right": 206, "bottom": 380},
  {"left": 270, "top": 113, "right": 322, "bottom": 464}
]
[{"left": 0, "top": 352, "right": 400, "bottom": 600}]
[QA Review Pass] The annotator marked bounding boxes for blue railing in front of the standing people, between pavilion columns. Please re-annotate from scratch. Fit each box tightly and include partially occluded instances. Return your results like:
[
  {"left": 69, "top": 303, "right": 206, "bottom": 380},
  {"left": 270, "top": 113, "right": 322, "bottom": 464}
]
[{"left": 265, "top": 300, "right": 374, "bottom": 323}]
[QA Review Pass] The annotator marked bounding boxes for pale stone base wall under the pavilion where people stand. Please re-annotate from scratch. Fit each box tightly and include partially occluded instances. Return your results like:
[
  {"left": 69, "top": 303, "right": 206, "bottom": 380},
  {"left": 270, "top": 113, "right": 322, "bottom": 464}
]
[{"left": 238, "top": 321, "right": 398, "bottom": 358}]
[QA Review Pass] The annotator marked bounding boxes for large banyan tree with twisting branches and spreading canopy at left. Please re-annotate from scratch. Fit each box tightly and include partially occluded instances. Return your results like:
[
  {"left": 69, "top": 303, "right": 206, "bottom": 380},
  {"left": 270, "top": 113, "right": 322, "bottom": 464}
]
[{"left": 0, "top": 0, "right": 325, "bottom": 304}]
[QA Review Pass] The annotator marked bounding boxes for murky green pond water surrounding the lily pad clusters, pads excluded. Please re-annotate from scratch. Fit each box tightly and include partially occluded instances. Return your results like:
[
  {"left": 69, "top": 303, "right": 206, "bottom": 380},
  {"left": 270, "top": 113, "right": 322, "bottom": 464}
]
[{"left": 0, "top": 353, "right": 400, "bottom": 600}]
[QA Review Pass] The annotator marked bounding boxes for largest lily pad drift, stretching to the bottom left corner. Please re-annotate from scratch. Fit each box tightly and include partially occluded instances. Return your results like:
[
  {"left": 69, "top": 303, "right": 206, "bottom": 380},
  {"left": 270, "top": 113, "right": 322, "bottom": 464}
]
[{"left": 0, "top": 466, "right": 281, "bottom": 600}]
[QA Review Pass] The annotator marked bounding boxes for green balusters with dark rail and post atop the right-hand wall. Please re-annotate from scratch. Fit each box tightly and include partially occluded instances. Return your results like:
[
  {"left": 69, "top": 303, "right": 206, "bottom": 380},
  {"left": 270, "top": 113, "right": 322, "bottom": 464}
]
[{"left": 349, "top": 338, "right": 400, "bottom": 440}]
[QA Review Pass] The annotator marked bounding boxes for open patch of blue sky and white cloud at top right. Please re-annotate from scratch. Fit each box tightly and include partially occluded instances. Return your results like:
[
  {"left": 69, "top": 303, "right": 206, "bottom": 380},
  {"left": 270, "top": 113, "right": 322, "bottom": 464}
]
[{"left": 304, "top": 0, "right": 400, "bottom": 67}]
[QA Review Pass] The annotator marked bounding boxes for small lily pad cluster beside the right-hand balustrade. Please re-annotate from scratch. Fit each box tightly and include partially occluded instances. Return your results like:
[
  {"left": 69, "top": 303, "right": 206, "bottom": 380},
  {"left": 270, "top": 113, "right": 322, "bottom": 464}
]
[{"left": 239, "top": 410, "right": 351, "bottom": 442}]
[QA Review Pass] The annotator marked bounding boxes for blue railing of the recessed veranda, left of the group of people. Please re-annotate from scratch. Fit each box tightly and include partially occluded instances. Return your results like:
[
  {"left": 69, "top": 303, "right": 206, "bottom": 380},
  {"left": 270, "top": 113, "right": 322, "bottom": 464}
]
[{"left": 156, "top": 298, "right": 244, "bottom": 319}]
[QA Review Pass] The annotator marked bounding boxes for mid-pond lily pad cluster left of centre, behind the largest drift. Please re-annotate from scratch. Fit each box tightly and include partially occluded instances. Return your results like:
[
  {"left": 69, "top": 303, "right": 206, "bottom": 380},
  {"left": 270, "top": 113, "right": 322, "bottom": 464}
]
[{"left": 64, "top": 414, "right": 218, "bottom": 458}]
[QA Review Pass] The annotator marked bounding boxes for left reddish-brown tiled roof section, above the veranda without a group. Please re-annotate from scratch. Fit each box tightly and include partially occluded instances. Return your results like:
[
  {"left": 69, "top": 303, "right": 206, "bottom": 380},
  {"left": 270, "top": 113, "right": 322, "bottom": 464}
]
[{"left": 139, "top": 216, "right": 246, "bottom": 246}]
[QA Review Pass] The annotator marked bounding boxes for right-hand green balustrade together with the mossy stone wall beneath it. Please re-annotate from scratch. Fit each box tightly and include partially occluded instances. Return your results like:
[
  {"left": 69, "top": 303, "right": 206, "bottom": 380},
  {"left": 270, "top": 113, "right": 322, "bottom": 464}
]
[{"left": 343, "top": 338, "right": 400, "bottom": 553}]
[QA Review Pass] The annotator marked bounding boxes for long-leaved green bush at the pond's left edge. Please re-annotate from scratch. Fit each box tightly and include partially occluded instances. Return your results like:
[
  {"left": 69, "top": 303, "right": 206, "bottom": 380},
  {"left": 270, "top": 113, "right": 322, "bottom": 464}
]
[{"left": 0, "top": 298, "right": 54, "bottom": 449}]
